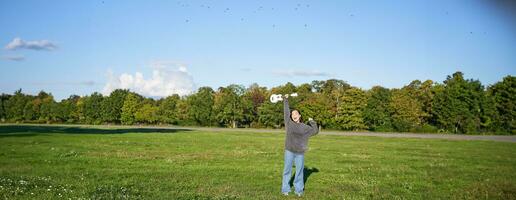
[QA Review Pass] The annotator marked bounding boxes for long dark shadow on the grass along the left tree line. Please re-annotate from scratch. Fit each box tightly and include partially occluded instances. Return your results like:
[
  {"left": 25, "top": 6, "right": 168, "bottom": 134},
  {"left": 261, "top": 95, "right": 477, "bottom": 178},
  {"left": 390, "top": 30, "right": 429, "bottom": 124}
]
[{"left": 0, "top": 125, "right": 190, "bottom": 137}]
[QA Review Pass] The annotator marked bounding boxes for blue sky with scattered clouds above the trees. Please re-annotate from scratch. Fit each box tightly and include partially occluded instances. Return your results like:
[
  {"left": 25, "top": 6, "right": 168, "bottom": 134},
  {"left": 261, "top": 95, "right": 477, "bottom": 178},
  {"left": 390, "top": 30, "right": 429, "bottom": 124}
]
[{"left": 0, "top": 0, "right": 516, "bottom": 99}]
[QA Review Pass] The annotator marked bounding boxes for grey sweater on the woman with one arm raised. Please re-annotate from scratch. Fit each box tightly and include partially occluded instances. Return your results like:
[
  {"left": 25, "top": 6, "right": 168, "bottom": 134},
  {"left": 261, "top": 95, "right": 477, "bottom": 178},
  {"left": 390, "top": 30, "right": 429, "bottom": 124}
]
[{"left": 283, "top": 98, "right": 319, "bottom": 153}]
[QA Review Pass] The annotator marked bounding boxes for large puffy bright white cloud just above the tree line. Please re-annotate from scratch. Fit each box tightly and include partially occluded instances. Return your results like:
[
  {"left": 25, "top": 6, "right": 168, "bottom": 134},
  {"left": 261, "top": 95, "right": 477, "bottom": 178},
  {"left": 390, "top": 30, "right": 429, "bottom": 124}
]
[{"left": 102, "top": 63, "right": 195, "bottom": 97}]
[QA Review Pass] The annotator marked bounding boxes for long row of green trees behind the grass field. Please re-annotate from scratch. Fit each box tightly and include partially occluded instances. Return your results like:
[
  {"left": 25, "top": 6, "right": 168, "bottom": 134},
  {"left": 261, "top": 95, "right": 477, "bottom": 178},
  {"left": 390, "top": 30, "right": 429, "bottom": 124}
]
[{"left": 0, "top": 72, "right": 516, "bottom": 134}]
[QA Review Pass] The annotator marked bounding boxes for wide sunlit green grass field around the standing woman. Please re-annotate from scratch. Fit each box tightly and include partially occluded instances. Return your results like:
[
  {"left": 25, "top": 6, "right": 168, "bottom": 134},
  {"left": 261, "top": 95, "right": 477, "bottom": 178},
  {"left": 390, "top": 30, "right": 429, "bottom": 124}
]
[{"left": 0, "top": 125, "right": 516, "bottom": 199}]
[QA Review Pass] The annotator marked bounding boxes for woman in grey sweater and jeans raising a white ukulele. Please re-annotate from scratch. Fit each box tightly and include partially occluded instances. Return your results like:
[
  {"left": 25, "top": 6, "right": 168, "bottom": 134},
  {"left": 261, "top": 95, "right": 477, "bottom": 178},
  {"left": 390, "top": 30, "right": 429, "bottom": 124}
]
[{"left": 281, "top": 94, "right": 319, "bottom": 196}]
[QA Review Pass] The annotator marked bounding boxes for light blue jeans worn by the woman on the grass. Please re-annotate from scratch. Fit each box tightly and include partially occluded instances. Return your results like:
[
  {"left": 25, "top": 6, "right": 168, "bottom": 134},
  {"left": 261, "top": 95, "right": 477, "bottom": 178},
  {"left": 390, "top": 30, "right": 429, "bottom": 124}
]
[{"left": 281, "top": 150, "right": 305, "bottom": 193}]
